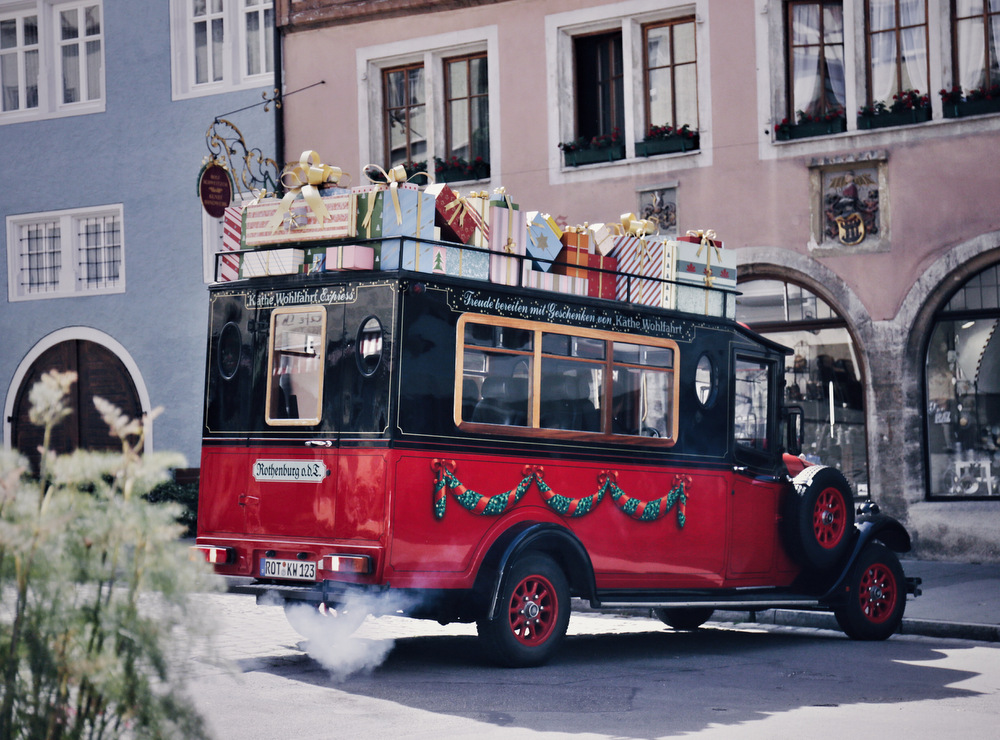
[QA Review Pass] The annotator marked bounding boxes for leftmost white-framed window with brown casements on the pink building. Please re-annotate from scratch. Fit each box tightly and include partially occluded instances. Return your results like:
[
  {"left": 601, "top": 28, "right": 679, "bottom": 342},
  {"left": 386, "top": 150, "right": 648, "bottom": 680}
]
[{"left": 358, "top": 26, "right": 499, "bottom": 181}]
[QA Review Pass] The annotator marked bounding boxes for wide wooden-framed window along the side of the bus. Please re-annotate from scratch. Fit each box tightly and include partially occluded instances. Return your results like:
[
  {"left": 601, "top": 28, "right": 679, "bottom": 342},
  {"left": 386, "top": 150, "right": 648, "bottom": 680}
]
[{"left": 455, "top": 314, "right": 677, "bottom": 444}]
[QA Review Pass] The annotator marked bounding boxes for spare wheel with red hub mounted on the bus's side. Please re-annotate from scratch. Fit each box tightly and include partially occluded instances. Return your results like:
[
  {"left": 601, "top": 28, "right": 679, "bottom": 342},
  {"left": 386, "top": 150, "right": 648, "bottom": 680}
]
[{"left": 785, "top": 465, "right": 854, "bottom": 571}]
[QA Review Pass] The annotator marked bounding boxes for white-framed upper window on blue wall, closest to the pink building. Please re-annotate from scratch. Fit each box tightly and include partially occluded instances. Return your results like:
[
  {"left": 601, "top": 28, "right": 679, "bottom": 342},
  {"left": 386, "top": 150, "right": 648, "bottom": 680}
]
[{"left": 170, "top": 0, "right": 274, "bottom": 99}]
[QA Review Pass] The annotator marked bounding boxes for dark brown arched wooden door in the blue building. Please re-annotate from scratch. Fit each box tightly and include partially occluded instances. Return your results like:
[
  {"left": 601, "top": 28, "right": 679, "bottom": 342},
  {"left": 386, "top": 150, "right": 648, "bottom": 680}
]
[{"left": 10, "top": 339, "right": 142, "bottom": 471}]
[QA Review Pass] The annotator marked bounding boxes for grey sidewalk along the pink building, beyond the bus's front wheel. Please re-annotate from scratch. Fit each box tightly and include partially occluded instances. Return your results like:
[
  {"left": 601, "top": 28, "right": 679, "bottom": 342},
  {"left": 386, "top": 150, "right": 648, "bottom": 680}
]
[{"left": 714, "top": 560, "right": 1000, "bottom": 642}]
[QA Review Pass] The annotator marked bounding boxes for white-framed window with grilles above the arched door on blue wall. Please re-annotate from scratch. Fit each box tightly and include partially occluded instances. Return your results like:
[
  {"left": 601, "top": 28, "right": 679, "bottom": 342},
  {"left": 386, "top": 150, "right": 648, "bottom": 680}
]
[{"left": 7, "top": 204, "right": 125, "bottom": 301}]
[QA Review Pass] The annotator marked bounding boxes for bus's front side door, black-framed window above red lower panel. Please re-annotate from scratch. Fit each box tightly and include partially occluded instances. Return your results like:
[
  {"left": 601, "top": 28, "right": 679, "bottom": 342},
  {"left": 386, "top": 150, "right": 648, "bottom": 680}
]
[{"left": 728, "top": 352, "right": 782, "bottom": 578}]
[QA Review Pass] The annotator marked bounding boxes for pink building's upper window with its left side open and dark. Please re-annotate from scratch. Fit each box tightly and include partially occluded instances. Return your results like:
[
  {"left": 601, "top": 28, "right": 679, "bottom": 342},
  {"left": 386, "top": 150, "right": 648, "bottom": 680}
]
[{"left": 546, "top": 0, "right": 708, "bottom": 166}]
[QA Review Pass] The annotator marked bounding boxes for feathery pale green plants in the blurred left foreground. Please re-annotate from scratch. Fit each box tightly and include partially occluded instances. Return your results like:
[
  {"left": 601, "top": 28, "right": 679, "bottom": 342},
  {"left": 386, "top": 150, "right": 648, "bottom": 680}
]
[{"left": 0, "top": 372, "right": 215, "bottom": 739}]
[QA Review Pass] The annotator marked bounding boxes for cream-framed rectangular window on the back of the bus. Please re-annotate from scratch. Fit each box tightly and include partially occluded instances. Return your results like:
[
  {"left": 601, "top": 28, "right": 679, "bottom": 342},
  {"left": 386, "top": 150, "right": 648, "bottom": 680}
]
[{"left": 265, "top": 307, "right": 326, "bottom": 426}]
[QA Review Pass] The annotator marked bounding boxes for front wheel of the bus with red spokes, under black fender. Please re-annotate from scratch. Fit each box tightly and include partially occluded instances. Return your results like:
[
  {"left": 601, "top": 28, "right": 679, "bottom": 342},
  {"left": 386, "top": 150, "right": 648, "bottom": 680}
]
[{"left": 833, "top": 542, "right": 906, "bottom": 640}]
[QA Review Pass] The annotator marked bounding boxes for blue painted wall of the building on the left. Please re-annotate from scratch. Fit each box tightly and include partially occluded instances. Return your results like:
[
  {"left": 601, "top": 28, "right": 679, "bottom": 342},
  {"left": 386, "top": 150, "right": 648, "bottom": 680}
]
[{"left": 0, "top": 0, "right": 275, "bottom": 467}]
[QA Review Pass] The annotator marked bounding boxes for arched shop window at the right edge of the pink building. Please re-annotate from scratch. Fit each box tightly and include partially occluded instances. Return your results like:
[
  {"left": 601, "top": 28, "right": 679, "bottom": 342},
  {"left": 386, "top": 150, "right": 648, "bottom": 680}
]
[{"left": 924, "top": 265, "right": 1000, "bottom": 499}]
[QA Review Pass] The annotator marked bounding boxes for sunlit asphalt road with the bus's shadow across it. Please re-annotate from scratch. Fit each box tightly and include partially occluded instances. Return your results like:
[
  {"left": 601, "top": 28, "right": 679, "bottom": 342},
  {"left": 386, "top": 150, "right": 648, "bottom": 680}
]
[{"left": 186, "top": 594, "right": 1000, "bottom": 740}]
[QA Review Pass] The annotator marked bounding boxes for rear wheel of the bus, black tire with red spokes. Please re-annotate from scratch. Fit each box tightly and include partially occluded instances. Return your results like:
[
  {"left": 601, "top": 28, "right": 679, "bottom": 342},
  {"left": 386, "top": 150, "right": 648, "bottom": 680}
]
[{"left": 476, "top": 554, "right": 570, "bottom": 668}]
